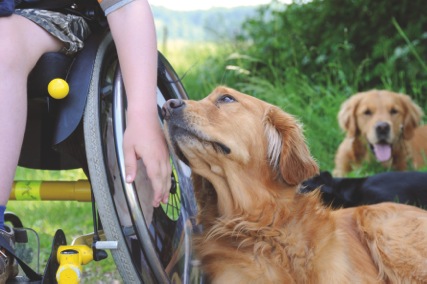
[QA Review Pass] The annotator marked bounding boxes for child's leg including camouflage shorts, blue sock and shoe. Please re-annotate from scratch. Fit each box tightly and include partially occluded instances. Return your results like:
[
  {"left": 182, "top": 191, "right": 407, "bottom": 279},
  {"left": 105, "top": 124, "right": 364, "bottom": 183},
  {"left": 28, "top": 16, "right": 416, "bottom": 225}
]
[{"left": 0, "top": 12, "right": 90, "bottom": 283}]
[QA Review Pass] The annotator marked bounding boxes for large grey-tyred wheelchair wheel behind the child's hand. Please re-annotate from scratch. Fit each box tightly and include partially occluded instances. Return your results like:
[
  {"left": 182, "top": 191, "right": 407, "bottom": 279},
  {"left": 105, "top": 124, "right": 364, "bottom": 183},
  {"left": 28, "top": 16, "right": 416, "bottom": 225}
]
[{"left": 84, "top": 34, "right": 201, "bottom": 283}]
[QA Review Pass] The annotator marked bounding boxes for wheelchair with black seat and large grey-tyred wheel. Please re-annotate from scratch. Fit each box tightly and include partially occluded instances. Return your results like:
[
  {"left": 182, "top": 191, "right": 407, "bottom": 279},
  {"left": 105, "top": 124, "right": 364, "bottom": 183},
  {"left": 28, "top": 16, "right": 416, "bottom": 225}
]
[{"left": 9, "top": 0, "right": 203, "bottom": 283}]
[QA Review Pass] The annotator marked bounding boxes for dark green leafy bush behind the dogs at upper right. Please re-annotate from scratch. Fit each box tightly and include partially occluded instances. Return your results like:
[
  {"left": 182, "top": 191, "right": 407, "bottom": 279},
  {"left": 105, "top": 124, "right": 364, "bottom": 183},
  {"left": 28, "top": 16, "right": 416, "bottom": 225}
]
[{"left": 239, "top": 0, "right": 427, "bottom": 102}]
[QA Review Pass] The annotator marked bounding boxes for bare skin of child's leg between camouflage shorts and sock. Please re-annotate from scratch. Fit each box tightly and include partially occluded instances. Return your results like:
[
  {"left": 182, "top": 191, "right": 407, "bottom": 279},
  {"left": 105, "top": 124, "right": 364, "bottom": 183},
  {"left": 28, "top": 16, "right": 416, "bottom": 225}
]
[{"left": 0, "top": 15, "right": 62, "bottom": 215}]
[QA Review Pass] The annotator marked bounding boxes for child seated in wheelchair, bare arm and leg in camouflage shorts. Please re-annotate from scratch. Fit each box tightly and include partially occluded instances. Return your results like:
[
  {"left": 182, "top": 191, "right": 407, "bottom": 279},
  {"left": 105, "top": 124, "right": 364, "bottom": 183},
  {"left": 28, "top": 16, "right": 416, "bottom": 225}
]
[{"left": 0, "top": 0, "right": 171, "bottom": 283}]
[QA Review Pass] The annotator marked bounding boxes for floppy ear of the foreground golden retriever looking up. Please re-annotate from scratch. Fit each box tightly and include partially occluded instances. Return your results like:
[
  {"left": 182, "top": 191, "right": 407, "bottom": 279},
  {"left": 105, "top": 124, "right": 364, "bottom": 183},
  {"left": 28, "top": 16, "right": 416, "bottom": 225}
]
[{"left": 264, "top": 106, "right": 319, "bottom": 185}]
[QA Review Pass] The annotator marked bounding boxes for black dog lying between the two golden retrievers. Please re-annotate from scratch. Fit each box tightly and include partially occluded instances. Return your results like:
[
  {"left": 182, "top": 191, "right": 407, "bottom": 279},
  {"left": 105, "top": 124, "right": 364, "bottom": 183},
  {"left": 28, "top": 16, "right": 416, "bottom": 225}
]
[{"left": 300, "top": 172, "right": 427, "bottom": 209}]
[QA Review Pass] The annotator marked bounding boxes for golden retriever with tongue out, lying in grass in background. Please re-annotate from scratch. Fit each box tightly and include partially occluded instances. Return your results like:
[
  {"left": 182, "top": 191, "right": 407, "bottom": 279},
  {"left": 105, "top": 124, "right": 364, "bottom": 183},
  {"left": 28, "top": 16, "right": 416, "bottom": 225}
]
[{"left": 333, "top": 90, "right": 427, "bottom": 177}]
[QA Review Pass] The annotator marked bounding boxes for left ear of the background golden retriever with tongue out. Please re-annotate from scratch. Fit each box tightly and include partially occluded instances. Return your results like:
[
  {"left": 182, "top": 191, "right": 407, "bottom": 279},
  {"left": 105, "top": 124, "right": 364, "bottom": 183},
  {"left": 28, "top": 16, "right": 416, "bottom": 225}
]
[{"left": 337, "top": 95, "right": 360, "bottom": 137}]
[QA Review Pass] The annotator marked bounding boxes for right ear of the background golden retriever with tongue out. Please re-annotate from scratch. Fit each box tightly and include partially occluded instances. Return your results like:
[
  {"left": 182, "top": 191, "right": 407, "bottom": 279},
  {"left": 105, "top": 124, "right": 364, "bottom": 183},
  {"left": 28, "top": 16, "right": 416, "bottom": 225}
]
[{"left": 399, "top": 94, "right": 424, "bottom": 140}]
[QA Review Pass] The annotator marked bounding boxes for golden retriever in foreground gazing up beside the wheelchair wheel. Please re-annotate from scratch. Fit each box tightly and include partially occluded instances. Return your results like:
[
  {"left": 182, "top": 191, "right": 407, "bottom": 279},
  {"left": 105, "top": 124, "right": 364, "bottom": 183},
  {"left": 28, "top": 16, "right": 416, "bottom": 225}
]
[{"left": 163, "top": 87, "right": 427, "bottom": 284}]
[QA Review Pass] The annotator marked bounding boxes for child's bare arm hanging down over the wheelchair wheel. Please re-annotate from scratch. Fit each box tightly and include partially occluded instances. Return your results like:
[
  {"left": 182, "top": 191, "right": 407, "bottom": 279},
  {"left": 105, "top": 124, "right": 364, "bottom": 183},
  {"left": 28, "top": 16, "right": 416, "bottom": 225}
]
[{"left": 107, "top": 0, "right": 171, "bottom": 207}]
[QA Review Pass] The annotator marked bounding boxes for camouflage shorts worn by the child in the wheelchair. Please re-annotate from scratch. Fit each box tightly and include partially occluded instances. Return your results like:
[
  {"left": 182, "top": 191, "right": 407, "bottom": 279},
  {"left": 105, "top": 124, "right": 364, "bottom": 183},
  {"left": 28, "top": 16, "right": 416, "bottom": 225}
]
[{"left": 15, "top": 9, "right": 90, "bottom": 55}]
